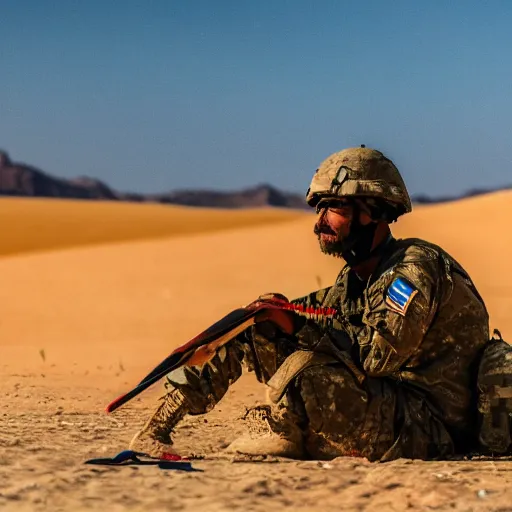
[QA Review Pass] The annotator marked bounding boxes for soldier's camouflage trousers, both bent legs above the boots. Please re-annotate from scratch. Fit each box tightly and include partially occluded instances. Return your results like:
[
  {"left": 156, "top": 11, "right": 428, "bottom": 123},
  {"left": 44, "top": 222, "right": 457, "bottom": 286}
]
[{"left": 168, "top": 324, "right": 454, "bottom": 461}]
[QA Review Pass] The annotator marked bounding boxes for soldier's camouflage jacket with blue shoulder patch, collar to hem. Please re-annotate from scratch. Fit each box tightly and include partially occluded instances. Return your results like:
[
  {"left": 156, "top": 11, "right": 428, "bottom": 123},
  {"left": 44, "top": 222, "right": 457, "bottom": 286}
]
[{"left": 297, "top": 239, "right": 489, "bottom": 433}]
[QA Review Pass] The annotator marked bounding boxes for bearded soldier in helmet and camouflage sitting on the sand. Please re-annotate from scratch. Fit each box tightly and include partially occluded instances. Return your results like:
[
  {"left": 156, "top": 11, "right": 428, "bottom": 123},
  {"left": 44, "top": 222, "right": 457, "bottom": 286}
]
[{"left": 132, "top": 146, "right": 512, "bottom": 461}]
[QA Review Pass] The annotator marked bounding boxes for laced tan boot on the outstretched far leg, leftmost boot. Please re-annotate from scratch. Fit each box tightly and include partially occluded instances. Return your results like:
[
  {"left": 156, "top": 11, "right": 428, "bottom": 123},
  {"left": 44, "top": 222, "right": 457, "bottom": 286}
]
[{"left": 130, "top": 389, "right": 189, "bottom": 457}]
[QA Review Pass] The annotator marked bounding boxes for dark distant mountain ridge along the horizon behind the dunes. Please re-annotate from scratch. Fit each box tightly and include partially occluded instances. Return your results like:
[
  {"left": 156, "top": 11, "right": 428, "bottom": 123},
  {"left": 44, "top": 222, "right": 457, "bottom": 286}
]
[{"left": 0, "top": 151, "right": 512, "bottom": 209}]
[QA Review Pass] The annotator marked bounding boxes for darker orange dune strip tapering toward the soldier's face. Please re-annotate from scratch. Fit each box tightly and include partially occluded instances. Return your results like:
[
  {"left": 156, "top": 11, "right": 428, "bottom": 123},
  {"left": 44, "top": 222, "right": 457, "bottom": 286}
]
[{"left": 0, "top": 197, "right": 304, "bottom": 256}]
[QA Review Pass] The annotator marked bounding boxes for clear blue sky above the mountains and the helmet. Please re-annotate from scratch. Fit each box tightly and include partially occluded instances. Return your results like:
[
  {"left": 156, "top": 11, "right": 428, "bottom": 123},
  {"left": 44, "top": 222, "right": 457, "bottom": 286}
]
[{"left": 0, "top": 0, "right": 512, "bottom": 195}]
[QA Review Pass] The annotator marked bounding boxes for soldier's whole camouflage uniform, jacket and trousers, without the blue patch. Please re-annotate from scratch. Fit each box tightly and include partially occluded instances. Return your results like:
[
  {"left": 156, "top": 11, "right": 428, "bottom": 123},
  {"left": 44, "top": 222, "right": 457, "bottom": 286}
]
[{"left": 159, "top": 234, "right": 489, "bottom": 460}]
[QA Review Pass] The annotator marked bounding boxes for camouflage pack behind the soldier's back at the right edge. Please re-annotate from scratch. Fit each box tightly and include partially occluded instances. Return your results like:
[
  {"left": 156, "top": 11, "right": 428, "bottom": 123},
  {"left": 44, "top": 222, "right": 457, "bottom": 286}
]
[{"left": 477, "top": 330, "right": 512, "bottom": 455}]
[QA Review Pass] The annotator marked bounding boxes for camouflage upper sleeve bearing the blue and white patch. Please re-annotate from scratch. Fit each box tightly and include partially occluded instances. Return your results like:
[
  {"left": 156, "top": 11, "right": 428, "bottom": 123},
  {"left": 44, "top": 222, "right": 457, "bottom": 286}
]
[{"left": 361, "top": 260, "right": 442, "bottom": 377}]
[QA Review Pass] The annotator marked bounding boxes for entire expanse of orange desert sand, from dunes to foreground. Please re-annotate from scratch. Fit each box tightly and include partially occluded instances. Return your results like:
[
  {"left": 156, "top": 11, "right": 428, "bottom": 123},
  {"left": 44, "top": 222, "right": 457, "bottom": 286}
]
[{"left": 0, "top": 193, "right": 512, "bottom": 512}]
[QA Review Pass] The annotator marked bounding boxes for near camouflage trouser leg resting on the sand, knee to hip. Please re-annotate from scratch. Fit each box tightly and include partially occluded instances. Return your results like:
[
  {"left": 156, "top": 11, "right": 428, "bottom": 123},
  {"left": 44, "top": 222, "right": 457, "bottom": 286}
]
[{"left": 264, "top": 354, "right": 454, "bottom": 461}]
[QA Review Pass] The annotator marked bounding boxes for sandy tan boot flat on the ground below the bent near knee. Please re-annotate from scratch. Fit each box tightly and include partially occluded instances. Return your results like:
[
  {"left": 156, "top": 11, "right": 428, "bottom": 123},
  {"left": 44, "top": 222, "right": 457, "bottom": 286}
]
[{"left": 225, "top": 405, "right": 305, "bottom": 459}]
